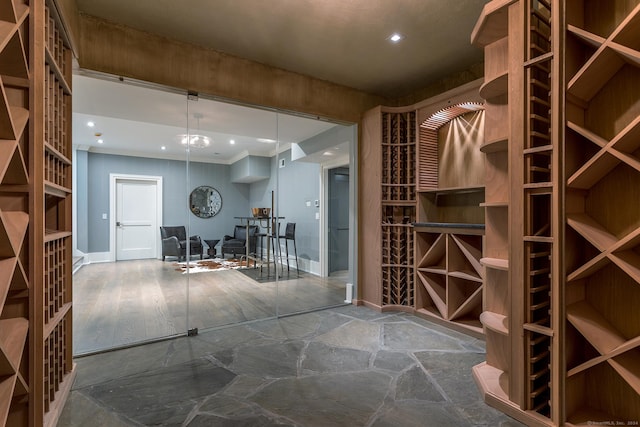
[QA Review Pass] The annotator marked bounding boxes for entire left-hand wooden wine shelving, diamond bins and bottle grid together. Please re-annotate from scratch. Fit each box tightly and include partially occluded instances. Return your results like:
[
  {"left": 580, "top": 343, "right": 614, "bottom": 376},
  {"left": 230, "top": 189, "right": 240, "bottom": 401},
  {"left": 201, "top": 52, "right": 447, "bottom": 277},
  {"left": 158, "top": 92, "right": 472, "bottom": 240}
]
[{"left": 0, "top": 0, "right": 73, "bottom": 426}]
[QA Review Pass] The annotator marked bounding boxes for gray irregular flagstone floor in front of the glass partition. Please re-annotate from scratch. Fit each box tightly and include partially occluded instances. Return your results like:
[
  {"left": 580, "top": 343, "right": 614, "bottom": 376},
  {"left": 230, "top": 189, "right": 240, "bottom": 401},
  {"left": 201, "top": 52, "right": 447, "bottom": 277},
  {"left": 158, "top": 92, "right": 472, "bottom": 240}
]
[{"left": 58, "top": 306, "right": 522, "bottom": 427}]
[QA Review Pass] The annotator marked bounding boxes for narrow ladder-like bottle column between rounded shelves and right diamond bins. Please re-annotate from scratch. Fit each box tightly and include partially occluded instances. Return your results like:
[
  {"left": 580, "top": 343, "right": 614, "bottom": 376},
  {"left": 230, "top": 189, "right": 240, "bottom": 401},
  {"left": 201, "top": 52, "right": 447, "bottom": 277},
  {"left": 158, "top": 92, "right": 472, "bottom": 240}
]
[{"left": 524, "top": 0, "right": 559, "bottom": 418}]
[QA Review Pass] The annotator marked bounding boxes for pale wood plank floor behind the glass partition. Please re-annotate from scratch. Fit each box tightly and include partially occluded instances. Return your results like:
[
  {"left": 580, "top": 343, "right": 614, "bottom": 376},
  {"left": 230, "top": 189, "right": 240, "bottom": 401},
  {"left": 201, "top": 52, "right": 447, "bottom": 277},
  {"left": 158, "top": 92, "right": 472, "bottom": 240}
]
[{"left": 73, "top": 259, "right": 346, "bottom": 355}]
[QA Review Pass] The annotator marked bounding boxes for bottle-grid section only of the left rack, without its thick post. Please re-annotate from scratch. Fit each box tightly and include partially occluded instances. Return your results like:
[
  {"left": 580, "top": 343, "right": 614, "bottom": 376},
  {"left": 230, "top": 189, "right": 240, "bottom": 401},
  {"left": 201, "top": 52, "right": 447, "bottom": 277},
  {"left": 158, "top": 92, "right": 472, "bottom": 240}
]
[{"left": 38, "top": 1, "right": 73, "bottom": 425}]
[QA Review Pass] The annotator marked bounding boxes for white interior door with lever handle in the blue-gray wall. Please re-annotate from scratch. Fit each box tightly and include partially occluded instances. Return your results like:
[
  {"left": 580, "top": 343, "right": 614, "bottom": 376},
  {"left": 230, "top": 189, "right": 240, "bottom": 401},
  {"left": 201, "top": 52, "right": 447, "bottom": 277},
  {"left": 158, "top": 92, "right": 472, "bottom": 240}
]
[{"left": 116, "top": 179, "right": 158, "bottom": 261}]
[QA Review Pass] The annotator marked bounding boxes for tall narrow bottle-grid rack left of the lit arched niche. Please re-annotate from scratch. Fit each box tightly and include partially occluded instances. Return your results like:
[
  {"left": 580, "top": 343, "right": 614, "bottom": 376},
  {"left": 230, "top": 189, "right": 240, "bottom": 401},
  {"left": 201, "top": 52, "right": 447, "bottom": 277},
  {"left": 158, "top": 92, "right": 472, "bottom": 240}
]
[{"left": 381, "top": 111, "right": 416, "bottom": 307}]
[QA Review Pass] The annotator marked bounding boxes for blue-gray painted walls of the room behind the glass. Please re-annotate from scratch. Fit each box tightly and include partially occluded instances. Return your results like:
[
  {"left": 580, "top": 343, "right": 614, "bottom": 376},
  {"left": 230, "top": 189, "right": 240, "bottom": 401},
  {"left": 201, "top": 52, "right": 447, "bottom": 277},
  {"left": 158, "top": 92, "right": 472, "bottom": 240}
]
[{"left": 76, "top": 152, "right": 320, "bottom": 261}]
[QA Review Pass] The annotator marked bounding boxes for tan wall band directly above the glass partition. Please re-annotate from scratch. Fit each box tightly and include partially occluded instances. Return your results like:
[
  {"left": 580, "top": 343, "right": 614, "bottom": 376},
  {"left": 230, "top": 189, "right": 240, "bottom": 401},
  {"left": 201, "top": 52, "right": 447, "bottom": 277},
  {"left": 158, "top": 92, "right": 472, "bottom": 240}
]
[{"left": 75, "top": 15, "right": 386, "bottom": 122}]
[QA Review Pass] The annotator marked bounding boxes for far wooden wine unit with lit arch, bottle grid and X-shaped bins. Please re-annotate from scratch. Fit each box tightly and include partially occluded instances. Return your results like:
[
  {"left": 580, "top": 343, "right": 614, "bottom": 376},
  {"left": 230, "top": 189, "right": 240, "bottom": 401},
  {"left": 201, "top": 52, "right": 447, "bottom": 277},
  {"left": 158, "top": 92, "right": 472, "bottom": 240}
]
[{"left": 357, "top": 82, "right": 484, "bottom": 328}]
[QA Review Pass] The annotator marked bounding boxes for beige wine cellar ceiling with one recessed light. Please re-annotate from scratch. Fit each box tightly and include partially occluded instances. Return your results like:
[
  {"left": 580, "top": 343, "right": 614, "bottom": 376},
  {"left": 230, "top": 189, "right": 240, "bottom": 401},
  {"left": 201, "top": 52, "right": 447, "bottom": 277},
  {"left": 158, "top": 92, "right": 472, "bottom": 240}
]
[{"left": 76, "top": 0, "right": 487, "bottom": 98}]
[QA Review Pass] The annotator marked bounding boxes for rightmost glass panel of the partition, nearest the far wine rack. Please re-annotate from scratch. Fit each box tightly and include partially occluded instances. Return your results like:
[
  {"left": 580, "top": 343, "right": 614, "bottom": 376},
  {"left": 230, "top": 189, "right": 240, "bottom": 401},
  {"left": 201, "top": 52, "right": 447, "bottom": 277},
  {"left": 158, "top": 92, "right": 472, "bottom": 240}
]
[{"left": 275, "top": 113, "right": 356, "bottom": 315}]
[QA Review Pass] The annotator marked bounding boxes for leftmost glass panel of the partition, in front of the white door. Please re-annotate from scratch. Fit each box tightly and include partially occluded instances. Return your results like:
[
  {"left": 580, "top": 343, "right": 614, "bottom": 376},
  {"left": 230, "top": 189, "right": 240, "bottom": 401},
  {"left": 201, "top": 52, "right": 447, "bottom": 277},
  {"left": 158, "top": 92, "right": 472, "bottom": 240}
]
[{"left": 73, "top": 73, "right": 190, "bottom": 355}]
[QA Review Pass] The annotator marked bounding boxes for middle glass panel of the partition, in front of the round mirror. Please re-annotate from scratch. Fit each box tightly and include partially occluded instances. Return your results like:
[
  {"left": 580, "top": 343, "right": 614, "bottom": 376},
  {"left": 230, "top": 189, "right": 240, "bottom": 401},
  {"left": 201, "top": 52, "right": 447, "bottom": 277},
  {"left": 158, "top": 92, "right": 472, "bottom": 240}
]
[{"left": 185, "top": 96, "right": 277, "bottom": 332}]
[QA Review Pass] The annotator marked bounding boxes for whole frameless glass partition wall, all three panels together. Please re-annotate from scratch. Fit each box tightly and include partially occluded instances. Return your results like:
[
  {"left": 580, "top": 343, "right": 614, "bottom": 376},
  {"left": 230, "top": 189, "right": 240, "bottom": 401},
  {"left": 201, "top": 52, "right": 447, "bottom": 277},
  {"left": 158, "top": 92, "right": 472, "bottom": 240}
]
[{"left": 73, "top": 74, "right": 357, "bottom": 355}]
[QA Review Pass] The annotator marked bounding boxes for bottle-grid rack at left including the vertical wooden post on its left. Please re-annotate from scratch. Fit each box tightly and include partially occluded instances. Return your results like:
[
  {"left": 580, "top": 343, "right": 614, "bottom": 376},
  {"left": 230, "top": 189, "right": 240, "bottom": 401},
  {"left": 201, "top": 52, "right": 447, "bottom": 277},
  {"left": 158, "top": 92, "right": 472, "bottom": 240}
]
[{"left": 29, "top": 0, "right": 75, "bottom": 426}]
